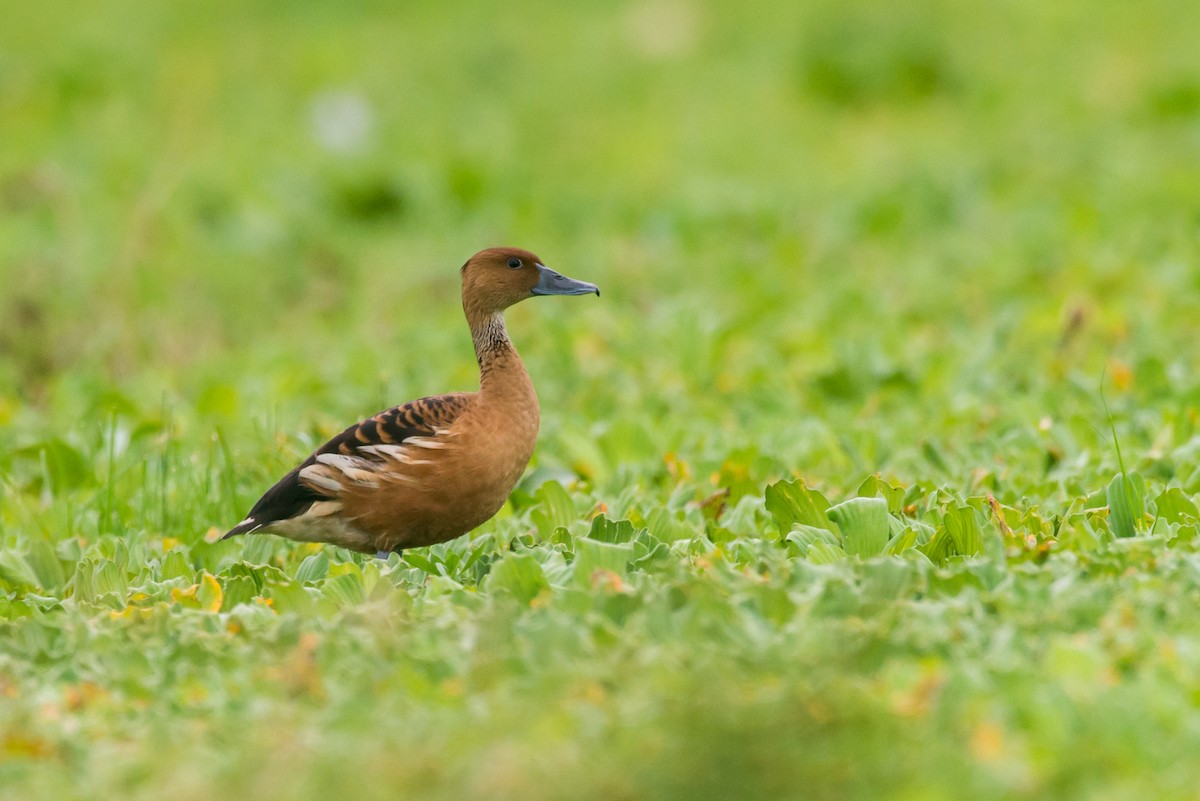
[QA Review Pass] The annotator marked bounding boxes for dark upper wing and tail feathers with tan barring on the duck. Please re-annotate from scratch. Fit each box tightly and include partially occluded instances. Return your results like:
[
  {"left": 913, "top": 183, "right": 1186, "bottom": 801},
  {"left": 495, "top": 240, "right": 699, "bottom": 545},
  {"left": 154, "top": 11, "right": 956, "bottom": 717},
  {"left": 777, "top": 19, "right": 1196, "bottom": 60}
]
[{"left": 222, "top": 392, "right": 470, "bottom": 540}]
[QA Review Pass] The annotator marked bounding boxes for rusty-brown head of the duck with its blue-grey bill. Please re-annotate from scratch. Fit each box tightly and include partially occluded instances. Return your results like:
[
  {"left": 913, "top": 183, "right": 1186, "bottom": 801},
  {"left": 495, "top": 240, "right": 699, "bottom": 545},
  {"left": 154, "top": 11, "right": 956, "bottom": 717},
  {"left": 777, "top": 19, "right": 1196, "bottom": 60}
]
[{"left": 462, "top": 247, "right": 600, "bottom": 314}]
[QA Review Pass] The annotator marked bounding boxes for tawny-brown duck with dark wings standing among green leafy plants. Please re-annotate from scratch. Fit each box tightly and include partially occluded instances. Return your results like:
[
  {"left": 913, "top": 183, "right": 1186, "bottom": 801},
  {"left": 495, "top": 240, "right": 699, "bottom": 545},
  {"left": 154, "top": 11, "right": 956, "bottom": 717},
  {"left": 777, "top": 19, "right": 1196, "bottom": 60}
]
[{"left": 221, "top": 247, "right": 600, "bottom": 559}]
